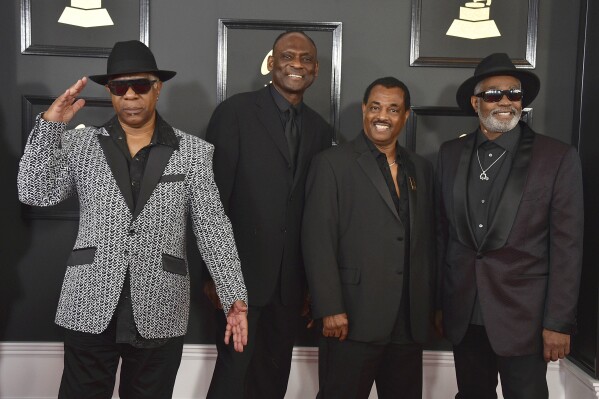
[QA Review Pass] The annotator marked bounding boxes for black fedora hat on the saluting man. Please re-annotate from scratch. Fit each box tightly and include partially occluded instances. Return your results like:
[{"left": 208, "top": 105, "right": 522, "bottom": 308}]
[{"left": 89, "top": 40, "right": 177, "bottom": 85}]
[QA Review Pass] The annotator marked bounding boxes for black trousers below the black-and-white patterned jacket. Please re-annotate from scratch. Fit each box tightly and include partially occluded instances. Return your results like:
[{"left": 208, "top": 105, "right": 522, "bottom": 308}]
[{"left": 58, "top": 320, "right": 183, "bottom": 399}]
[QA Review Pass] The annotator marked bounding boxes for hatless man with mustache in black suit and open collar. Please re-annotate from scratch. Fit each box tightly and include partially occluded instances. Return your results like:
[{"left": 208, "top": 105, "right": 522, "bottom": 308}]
[{"left": 302, "top": 77, "right": 436, "bottom": 399}]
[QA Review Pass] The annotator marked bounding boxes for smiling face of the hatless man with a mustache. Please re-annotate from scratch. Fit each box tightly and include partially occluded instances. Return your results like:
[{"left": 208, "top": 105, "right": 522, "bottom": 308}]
[{"left": 362, "top": 85, "right": 410, "bottom": 152}]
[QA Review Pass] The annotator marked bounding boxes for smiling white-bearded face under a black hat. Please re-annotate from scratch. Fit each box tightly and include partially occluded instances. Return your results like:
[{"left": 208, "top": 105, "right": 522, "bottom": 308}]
[{"left": 470, "top": 76, "right": 526, "bottom": 140}]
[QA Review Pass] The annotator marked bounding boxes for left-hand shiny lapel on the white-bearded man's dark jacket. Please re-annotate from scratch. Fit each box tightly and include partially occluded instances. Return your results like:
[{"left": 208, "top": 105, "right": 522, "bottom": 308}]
[{"left": 453, "top": 133, "right": 477, "bottom": 248}]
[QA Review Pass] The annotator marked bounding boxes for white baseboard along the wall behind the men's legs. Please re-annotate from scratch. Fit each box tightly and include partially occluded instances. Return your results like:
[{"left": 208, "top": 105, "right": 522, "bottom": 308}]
[{"left": 0, "top": 342, "right": 599, "bottom": 399}]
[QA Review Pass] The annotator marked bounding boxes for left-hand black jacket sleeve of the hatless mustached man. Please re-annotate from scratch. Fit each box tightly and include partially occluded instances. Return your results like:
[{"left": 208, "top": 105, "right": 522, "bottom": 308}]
[{"left": 302, "top": 154, "right": 345, "bottom": 319}]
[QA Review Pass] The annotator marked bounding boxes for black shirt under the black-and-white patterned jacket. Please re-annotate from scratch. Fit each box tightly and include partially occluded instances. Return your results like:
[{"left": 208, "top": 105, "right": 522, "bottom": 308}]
[{"left": 104, "top": 114, "right": 179, "bottom": 348}]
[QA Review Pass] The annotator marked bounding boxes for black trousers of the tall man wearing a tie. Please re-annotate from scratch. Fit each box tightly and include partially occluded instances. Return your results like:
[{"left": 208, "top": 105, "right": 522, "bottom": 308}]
[{"left": 207, "top": 295, "right": 301, "bottom": 399}]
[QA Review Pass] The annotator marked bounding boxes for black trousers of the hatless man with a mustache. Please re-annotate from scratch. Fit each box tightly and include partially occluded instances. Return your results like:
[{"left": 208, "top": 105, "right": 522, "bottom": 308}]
[{"left": 317, "top": 337, "right": 422, "bottom": 399}]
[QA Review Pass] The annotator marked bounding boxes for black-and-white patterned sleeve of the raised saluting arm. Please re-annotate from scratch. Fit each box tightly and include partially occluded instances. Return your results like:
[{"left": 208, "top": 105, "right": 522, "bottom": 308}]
[{"left": 17, "top": 114, "right": 76, "bottom": 206}]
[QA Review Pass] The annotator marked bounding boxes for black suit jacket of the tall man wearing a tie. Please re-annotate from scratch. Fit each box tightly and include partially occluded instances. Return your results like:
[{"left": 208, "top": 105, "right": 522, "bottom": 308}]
[{"left": 206, "top": 87, "right": 332, "bottom": 306}]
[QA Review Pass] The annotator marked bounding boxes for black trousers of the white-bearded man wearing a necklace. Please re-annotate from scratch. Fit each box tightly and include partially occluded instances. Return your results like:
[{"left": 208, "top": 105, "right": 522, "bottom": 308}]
[{"left": 453, "top": 324, "right": 549, "bottom": 399}]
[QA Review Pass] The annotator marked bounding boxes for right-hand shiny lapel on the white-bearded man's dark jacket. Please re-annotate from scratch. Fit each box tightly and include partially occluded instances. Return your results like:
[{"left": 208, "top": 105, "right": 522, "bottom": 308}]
[{"left": 480, "top": 124, "right": 535, "bottom": 252}]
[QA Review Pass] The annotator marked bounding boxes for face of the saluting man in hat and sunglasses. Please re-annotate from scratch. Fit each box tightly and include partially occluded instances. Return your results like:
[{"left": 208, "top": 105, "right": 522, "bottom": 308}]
[{"left": 107, "top": 73, "right": 162, "bottom": 129}]
